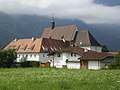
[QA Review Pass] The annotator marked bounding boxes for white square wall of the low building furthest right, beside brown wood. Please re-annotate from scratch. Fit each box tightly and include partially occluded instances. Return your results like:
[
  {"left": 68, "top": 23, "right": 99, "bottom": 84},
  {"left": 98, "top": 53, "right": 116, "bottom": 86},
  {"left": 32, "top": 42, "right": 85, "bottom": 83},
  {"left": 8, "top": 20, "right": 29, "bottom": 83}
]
[{"left": 88, "top": 61, "right": 101, "bottom": 70}]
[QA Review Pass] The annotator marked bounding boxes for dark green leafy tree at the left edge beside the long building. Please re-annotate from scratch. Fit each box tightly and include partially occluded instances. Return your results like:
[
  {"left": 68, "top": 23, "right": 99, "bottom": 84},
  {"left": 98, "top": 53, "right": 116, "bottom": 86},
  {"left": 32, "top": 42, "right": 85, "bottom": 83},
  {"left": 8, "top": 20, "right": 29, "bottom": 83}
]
[{"left": 0, "top": 49, "right": 17, "bottom": 68}]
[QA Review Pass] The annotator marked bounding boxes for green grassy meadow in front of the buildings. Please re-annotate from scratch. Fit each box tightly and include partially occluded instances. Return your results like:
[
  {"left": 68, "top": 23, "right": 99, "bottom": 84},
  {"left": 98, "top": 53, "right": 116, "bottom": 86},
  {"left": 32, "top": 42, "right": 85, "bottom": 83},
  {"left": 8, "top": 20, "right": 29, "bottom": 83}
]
[{"left": 0, "top": 68, "right": 120, "bottom": 90}]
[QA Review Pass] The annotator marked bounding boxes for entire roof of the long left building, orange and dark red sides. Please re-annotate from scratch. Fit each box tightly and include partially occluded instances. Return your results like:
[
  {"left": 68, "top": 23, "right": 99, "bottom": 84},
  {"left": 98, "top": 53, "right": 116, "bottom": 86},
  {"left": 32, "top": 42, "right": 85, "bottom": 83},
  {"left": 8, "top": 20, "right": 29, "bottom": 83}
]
[{"left": 5, "top": 38, "right": 69, "bottom": 53}]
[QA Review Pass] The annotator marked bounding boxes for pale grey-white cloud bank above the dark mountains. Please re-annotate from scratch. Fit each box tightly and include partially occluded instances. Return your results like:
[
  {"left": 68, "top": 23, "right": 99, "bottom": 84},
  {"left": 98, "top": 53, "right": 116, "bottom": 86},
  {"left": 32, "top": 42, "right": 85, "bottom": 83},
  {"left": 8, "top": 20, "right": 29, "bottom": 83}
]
[{"left": 0, "top": 0, "right": 120, "bottom": 24}]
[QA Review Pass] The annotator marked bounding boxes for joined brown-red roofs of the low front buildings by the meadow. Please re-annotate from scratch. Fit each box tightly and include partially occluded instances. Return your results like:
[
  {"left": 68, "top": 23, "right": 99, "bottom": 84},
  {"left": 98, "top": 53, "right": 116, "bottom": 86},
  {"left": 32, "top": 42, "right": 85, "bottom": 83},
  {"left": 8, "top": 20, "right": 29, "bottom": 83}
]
[{"left": 49, "top": 46, "right": 108, "bottom": 60}]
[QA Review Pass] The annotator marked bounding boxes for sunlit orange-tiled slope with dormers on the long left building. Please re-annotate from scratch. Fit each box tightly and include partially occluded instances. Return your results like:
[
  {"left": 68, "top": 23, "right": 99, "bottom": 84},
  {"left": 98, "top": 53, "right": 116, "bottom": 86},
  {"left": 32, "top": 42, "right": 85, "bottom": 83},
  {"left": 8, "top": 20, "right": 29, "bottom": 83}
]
[{"left": 5, "top": 38, "right": 42, "bottom": 53}]
